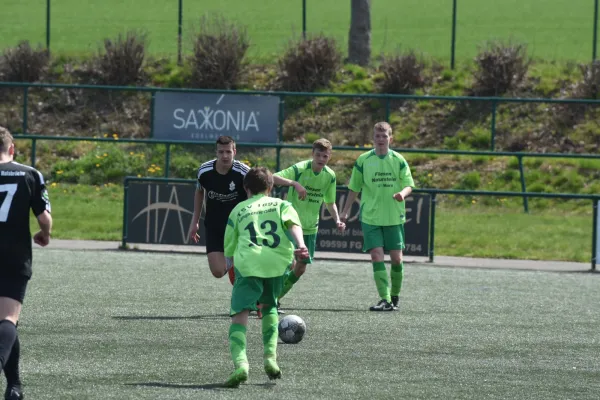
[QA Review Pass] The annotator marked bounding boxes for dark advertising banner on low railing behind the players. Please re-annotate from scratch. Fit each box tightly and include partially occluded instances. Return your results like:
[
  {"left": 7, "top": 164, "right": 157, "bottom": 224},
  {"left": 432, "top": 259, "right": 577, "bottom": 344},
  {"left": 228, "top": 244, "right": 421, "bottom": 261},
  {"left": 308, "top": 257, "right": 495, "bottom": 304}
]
[{"left": 125, "top": 181, "right": 430, "bottom": 257}]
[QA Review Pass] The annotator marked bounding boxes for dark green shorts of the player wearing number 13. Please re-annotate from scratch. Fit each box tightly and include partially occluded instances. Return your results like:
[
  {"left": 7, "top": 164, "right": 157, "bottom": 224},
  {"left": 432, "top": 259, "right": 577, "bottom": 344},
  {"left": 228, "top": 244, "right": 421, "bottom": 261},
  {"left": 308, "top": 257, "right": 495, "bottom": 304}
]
[{"left": 229, "top": 269, "right": 284, "bottom": 316}]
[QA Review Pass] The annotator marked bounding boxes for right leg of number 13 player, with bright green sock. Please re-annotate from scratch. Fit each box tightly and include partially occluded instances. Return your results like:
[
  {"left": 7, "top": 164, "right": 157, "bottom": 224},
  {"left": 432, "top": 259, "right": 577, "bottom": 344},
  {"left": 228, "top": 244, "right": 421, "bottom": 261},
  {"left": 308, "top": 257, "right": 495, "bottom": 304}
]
[{"left": 260, "top": 276, "right": 284, "bottom": 379}]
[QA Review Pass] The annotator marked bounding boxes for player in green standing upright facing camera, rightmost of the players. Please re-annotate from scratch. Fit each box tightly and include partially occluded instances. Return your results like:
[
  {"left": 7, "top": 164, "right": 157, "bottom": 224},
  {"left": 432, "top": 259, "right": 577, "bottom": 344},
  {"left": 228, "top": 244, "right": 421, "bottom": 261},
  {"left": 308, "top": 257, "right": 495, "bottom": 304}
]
[{"left": 342, "top": 122, "right": 415, "bottom": 311}]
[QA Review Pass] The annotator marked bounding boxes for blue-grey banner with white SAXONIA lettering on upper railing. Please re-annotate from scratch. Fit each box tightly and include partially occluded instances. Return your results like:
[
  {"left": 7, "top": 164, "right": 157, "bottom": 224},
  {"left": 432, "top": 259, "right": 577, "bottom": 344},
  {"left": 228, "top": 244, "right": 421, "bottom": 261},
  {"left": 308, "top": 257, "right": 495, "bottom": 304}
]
[{"left": 153, "top": 92, "right": 279, "bottom": 143}]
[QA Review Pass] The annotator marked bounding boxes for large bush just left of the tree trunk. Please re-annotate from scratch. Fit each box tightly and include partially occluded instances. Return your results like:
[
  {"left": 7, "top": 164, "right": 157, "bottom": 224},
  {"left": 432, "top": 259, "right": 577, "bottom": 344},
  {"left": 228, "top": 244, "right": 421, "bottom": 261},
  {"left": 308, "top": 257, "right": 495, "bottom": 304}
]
[{"left": 277, "top": 34, "right": 342, "bottom": 92}]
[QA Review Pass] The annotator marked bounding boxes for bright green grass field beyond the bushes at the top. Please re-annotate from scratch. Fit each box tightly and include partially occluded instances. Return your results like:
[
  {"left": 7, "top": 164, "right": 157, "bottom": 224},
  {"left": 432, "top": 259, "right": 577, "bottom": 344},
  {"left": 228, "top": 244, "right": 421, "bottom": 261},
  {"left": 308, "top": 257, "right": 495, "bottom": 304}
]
[{"left": 0, "top": 0, "right": 594, "bottom": 61}]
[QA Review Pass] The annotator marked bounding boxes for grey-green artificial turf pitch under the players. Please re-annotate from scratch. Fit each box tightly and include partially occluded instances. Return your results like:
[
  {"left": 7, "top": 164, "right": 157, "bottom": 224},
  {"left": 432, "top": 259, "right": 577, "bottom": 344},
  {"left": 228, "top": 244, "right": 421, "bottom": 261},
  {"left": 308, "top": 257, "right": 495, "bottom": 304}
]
[{"left": 8, "top": 249, "right": 600, "bottom": 400}]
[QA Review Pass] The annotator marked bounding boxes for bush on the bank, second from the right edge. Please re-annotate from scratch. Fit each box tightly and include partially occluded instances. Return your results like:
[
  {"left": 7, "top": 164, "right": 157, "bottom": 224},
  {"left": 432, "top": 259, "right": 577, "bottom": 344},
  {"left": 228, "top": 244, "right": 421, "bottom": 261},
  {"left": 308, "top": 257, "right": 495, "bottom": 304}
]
[{"left": 472, "top": 42, "right": 531, "bottom": 96}]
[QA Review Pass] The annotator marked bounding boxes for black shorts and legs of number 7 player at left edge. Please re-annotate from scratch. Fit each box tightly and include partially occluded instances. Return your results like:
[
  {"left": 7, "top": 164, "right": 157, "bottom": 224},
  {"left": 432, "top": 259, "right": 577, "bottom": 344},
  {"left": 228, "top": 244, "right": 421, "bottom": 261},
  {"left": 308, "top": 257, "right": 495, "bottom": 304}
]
[{"left": 0, "top": 277, "right": 28, "bottom": 400}]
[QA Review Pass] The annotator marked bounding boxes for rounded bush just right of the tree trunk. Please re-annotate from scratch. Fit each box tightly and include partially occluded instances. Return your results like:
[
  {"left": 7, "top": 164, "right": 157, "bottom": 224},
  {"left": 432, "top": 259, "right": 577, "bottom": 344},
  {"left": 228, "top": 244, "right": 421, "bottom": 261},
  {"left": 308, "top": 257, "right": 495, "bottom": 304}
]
[{"left": 379, "top": 50, "right": 425, "bottom": 94}]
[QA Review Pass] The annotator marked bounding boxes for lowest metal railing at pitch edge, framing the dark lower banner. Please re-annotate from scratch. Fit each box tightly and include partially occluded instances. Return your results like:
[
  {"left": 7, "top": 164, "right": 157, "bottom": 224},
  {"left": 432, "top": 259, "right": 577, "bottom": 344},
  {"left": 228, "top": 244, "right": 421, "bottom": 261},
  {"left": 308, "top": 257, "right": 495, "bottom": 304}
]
[{"left": 121, "top": 176, "right": 600, "bottom": 271}]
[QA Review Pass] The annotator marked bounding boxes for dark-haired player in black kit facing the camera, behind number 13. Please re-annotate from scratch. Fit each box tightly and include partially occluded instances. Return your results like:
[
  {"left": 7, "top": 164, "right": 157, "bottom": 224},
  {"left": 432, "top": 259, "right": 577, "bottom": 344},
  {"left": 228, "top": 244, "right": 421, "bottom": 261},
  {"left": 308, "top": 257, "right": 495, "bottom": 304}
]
[{"left": 188, "top": 136, "right": 250, "bottom": 284}]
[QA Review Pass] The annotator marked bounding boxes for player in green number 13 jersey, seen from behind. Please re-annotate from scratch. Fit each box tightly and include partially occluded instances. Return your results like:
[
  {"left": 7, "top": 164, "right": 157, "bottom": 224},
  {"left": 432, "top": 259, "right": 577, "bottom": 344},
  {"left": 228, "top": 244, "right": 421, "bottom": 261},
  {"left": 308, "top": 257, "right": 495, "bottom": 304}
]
[{"left": 225, "top": 167, "right": 308, "bottom": 387}]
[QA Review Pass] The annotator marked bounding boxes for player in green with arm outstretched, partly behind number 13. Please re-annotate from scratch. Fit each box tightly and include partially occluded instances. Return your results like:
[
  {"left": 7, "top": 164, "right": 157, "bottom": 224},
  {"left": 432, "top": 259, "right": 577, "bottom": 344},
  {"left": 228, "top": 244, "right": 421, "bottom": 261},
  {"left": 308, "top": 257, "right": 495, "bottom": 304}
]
[{"left": 273, "top": 139, "right": 346, "bottom": 304}]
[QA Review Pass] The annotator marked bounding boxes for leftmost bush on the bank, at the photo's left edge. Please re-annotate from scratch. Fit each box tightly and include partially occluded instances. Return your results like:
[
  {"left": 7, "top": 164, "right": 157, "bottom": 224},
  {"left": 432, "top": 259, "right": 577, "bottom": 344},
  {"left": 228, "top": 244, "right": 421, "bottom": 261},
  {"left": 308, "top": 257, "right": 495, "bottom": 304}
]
[{"left": 0, "top": 41, "right": 50, "bottom": 82}]
